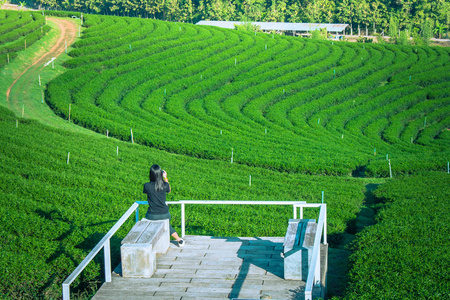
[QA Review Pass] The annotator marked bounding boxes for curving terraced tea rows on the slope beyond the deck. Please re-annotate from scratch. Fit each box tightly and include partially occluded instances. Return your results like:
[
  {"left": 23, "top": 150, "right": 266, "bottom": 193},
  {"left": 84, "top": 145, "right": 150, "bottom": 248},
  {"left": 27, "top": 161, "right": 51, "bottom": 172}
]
[{"left": 46, "top": 16, "right": 450, "bottom": 177}]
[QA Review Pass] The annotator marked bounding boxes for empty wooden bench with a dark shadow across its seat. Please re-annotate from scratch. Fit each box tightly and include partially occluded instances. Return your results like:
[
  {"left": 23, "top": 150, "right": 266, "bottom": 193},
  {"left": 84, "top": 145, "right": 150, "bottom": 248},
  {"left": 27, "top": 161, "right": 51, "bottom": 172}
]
[{"left": 283, "top": 219, "right": 317, "bottom": 281}]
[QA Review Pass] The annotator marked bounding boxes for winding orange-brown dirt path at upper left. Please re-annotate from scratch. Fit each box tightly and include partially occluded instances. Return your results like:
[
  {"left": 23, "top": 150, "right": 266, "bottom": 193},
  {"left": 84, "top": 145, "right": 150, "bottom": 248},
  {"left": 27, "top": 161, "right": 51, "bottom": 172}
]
[{"left": 6, "top": 18, "right": 77, "bottom": 109}]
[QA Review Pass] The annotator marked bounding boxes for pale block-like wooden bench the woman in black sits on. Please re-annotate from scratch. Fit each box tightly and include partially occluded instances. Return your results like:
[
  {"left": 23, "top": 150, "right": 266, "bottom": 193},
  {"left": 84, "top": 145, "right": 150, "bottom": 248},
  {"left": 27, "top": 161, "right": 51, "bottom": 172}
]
[{"left": 120, "top": 220, "right": 170, "bottom": 278}]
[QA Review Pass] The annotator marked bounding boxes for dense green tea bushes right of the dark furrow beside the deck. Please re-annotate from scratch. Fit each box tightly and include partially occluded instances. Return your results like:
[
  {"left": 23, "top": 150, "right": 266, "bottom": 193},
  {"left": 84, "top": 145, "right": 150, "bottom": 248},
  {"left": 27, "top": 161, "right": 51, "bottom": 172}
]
[{"left": 345, "top": 172, "right": 450, "bottom": 299}]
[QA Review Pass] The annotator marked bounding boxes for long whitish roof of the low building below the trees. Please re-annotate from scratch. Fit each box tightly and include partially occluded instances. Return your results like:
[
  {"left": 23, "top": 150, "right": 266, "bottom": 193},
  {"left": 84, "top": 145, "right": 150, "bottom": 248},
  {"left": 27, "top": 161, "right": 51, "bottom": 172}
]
[{"left": 197, "top": 21, "right": 348, "bottom": 32}]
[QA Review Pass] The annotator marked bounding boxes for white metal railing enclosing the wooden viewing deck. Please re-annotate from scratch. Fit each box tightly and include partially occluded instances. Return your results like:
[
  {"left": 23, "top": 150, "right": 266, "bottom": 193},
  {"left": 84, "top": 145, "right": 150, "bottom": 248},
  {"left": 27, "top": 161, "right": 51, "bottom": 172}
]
[{"left": 62, "top": 200, "right": 327, "bottom": 300}]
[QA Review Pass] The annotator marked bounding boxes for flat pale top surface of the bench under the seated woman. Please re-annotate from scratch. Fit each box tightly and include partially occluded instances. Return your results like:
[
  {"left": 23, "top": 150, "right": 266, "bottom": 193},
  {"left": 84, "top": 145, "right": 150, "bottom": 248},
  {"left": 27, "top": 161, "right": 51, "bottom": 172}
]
[{"left": 122, "top": 220, "right": 164, "bottom": 246}]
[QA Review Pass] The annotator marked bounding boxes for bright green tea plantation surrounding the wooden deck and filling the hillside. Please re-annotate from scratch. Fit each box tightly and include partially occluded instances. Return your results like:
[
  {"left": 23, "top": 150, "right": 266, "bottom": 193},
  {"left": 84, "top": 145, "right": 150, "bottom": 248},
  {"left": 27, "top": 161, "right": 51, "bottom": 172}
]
[{"left": 0, "top": 11, "right": 450, "bottom": 299}]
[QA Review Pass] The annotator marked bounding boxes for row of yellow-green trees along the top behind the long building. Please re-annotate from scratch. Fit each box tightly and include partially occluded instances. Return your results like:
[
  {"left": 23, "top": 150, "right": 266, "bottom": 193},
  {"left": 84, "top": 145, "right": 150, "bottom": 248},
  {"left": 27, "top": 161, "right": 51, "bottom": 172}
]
[{"left": 21, "top": 0, "right": 450, "bottom": 37}]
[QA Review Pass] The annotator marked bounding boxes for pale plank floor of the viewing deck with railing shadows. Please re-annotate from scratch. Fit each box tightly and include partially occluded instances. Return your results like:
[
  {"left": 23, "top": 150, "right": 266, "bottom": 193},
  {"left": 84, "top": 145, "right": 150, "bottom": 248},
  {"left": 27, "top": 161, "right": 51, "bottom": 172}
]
[{"left": 93, "top": 236, "right": 326, "bottom": 300}]
